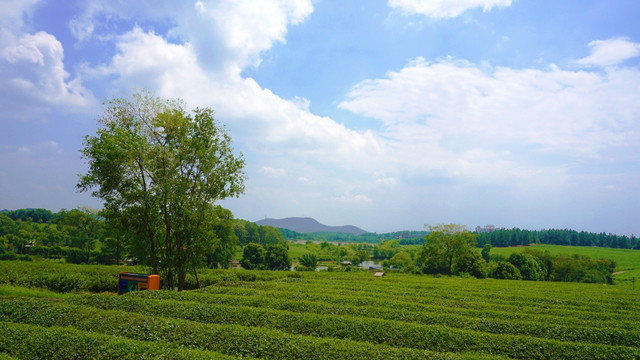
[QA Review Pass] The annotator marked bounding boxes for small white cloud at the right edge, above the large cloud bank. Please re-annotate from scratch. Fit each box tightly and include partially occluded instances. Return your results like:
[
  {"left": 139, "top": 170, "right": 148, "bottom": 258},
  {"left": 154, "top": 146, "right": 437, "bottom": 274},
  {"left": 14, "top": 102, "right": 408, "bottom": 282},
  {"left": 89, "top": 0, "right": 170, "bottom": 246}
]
[{"left": 577, "top": 38, "right": 640, "bottom": 66}]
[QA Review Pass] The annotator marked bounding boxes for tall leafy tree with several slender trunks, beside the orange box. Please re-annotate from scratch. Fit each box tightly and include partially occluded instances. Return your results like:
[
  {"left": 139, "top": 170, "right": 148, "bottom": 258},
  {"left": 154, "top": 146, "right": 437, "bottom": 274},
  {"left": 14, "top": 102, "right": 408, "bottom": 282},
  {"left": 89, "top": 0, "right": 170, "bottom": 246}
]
[{"left": 78, "top": 93, "right": 245, "bottom": 290}]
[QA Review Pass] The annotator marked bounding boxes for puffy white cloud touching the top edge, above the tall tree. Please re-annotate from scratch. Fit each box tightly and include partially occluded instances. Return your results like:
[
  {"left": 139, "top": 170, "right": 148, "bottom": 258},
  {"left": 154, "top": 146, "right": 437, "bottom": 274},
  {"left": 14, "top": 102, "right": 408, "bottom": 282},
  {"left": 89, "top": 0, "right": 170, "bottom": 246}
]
[{"left": 69, "top": 0, "right": 313, "bottom": 71}]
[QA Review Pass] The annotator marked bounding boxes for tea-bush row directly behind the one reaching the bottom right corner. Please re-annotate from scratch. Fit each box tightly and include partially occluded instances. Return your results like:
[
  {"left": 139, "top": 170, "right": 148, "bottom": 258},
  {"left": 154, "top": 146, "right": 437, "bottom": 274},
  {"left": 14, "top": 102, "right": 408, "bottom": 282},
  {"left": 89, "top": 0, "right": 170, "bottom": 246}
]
[{"left": 105, "top": 291, "right": 640, "bottom": 347}]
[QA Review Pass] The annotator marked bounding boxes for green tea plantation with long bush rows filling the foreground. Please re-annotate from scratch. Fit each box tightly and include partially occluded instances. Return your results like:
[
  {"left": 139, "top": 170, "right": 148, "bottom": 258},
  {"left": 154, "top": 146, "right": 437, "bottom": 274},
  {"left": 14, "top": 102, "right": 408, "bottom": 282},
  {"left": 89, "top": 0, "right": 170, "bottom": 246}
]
[{"left": 0, "top": 262, "right": 640, "bottom": 359}]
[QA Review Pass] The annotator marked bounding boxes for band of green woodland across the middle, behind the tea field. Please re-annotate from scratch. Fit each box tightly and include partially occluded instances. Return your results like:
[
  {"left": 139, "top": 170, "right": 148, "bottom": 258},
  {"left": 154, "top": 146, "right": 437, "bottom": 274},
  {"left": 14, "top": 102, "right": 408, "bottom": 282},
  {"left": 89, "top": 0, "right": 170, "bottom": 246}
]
[{"left": 0, "top": 206, "right": 620, "bottom": 283}]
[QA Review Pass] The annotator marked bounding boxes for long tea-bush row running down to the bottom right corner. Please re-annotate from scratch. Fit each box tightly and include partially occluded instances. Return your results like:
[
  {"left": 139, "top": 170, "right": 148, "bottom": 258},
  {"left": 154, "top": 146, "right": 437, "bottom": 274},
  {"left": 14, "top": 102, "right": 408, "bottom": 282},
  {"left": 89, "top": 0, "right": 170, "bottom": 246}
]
[{"left": 67, "top": 296, "right": 640, "bottom": 359}]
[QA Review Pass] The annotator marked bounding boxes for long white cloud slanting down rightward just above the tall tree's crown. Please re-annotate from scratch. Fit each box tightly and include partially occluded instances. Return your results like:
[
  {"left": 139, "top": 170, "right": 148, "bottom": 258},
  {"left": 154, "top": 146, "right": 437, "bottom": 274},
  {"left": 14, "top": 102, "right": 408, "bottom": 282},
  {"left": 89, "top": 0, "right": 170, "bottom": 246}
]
[{"left": 93, "top": 27, "right": 382, "bottom": 174}]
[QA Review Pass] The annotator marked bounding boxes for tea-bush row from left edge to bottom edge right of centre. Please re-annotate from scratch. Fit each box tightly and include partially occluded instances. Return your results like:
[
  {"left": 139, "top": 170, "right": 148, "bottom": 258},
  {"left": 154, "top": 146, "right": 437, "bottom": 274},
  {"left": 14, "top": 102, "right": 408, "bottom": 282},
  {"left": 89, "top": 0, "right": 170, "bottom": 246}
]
[{"left": 0, "top": 299, "right": 497, "bottom": 360}]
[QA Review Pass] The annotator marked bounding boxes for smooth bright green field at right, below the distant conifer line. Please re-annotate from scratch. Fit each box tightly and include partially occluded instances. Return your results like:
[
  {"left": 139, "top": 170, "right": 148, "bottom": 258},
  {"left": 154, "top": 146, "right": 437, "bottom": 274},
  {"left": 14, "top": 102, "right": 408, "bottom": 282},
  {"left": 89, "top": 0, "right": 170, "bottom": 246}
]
[{"left": 491, "top": 245, "right": 640, "bottom": 288}]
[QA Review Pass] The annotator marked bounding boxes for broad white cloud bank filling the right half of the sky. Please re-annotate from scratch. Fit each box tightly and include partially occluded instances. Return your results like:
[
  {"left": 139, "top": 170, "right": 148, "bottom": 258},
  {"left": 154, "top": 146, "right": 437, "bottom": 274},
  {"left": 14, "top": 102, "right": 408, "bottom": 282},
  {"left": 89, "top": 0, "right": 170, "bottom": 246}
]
[{"left": 339, "top": 58, "right": 640, "bottom": 187}]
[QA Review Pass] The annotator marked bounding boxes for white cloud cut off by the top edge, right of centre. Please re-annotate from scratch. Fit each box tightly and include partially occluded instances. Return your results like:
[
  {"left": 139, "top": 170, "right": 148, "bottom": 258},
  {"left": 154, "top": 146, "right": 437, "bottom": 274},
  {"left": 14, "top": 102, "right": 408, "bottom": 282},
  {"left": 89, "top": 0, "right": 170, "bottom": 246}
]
[{"left": 388, "top": 0, "right": 512, "bottom": 19}]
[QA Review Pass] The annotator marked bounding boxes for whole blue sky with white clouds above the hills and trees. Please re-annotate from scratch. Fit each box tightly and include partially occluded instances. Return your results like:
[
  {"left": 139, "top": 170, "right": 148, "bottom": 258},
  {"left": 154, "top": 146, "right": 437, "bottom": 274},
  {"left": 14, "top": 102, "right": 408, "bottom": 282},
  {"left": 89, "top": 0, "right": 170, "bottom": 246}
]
[{"left": 0, "top": 0, "right": 640, "bottom": 235}]
